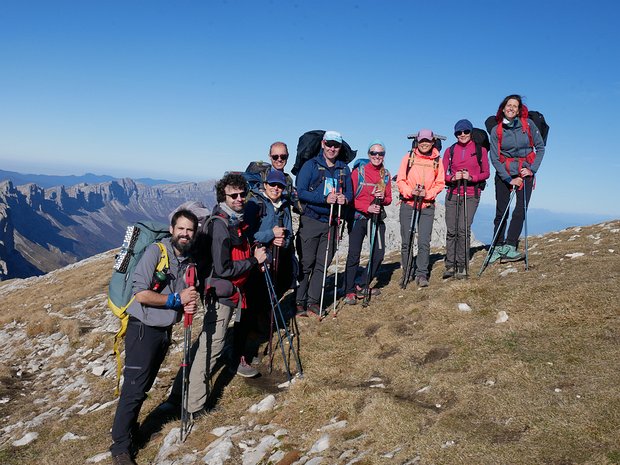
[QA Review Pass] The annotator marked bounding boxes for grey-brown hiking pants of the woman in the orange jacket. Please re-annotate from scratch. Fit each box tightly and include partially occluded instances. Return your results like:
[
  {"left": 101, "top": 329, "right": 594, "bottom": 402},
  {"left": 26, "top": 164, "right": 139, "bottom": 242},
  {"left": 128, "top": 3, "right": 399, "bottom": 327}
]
[{"left": 399, "top": 202, "right": 435, "bottom": 276}]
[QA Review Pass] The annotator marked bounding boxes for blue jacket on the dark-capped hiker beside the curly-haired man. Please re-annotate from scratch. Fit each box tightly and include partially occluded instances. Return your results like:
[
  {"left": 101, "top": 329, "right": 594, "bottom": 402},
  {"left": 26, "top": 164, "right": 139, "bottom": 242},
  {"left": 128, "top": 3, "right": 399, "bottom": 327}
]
[{"left": 243, "top": 192, "right": 293, "bottom": 248}]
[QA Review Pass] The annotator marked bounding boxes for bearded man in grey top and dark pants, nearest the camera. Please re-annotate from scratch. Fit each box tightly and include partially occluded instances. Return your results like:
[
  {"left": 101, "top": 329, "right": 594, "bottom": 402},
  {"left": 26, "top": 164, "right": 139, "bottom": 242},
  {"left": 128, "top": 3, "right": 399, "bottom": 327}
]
[{"left": 110, "top": 210, "right": 198, "bottom": 465}]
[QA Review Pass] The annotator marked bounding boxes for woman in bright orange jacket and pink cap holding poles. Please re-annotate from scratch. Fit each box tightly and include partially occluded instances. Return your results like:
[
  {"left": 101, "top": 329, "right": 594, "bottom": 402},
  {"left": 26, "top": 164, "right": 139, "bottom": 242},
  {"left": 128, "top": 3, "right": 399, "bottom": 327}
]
[{"left": 396, "top": 129, "right": 446, "bottom": 287}]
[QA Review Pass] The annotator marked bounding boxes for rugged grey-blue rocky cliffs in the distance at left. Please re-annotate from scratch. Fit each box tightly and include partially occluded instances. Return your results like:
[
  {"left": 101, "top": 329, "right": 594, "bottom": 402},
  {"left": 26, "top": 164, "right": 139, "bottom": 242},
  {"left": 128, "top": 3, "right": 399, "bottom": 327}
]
[{"left": 0, "top": 179, "right": 215, "bottom": 280}]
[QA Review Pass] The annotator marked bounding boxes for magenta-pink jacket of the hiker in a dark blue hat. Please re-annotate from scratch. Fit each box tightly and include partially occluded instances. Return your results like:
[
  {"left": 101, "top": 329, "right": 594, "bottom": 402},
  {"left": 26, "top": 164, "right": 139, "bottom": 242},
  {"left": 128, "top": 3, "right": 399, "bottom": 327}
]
[{"left": 442, "top": 140, "right": 490, "bottom": 196}]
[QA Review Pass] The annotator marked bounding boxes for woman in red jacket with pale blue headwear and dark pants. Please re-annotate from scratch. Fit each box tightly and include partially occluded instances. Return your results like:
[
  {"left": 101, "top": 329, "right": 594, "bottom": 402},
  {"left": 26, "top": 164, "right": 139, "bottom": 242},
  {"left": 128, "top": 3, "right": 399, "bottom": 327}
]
[{"left": 344, "top": 139, "right": 392, "bottom": 305}]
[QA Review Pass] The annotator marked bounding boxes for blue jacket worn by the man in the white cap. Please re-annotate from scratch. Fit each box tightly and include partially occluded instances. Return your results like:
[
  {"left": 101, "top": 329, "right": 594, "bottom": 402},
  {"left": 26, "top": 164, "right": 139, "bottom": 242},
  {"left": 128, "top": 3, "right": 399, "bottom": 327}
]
[{"left": 296, "top": 150, "right": 353, "bottom": 223}]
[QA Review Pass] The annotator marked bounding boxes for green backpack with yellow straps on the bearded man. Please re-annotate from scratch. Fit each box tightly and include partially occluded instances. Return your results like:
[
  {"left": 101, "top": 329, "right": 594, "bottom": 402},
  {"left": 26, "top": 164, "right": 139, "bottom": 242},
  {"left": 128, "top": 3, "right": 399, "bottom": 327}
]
[{"left": 108, "top": 221, "right": 170, "bottom": 395}]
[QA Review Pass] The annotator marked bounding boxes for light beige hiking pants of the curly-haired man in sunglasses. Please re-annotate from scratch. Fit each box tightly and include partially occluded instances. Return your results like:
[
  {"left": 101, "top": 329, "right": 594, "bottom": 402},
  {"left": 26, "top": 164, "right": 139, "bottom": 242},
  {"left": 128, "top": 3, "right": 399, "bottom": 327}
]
[{"left": 185, "top": 301, "right": 235, "bottom": 413}]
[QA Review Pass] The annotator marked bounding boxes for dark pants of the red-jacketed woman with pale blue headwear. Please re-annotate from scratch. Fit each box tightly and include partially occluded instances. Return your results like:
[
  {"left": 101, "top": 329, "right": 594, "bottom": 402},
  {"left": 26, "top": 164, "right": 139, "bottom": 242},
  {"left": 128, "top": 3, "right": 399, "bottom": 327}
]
[{"left": 344, "top": 218, "right": 385, "bottom": 295}]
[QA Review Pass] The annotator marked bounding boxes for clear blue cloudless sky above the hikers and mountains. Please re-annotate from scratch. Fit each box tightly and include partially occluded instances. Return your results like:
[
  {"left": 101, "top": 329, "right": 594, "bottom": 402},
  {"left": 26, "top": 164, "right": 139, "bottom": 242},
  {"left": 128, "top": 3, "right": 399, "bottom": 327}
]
[{"left": 0, "top": 0, "right": 620, "bottom": 216}]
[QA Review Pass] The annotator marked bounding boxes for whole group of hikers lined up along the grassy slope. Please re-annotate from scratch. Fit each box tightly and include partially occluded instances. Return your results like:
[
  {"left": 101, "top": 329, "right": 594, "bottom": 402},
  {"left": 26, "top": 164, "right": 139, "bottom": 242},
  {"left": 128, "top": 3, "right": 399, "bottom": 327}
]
[{"left": 111, "top": 95, "right": 544, "bottom": 464}]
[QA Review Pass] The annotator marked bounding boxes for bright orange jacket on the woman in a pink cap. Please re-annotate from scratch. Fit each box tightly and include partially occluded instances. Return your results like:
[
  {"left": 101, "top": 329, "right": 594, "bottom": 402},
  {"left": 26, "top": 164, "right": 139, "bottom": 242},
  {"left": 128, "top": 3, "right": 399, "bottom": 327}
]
[{"left": 396, "top": 147, "right": 446, "bottom": 207}]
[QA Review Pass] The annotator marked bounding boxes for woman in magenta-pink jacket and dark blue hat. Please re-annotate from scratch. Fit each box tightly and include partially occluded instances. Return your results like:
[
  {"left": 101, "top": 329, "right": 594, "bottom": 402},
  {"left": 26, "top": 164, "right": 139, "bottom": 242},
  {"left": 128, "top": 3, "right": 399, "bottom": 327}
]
[{"left": 442, "top": 119, "right": 489, "bottom": 279}]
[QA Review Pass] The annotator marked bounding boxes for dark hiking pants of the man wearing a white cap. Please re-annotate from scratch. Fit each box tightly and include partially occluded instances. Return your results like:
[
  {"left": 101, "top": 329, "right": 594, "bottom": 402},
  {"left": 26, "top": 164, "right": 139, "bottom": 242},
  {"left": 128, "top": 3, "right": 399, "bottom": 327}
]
[{"left": 296, "top": 214, "right": 338, "bottom": 304}]
